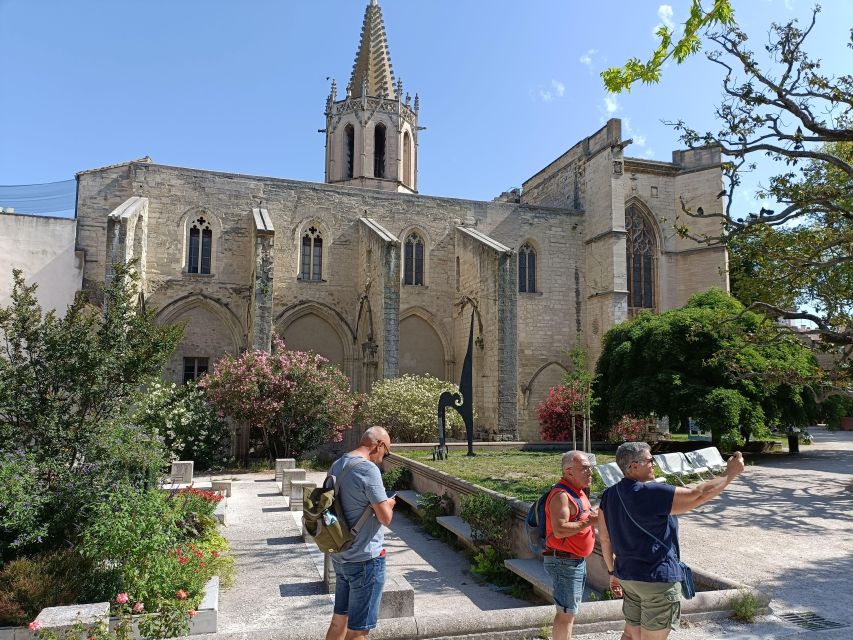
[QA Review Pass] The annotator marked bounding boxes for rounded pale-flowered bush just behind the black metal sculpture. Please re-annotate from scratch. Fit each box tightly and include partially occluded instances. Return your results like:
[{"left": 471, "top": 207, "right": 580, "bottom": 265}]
[{"left": 363, "top": 374, "right": 465, "bottom": 442}]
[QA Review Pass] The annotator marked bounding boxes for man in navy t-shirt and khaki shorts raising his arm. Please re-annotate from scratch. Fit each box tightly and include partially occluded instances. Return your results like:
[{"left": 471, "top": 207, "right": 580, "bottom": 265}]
[{"left": 598, "top": 442, "right": 743, "bottom": 640}]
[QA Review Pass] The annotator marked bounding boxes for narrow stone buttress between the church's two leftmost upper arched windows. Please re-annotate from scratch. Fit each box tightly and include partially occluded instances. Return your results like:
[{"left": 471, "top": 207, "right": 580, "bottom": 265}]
[{"left": 251, "top": 208, "right": 275, "bottom": 351}]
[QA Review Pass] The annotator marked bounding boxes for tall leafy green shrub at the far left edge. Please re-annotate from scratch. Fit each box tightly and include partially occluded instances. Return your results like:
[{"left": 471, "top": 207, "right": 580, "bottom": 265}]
[{"left": 0, "top": 265, "right": 182, "bottom": 561}]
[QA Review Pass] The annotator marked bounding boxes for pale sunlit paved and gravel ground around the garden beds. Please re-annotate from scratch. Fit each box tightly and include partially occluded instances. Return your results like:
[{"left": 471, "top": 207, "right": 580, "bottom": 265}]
[{"left": 205, "top": 430, "right": 853, "bottom": 640}]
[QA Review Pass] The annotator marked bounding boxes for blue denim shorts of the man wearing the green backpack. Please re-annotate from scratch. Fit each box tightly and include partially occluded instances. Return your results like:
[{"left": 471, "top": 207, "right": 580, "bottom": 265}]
[{"left": 332, "top": 556, "right": 385, "bottom": 631}]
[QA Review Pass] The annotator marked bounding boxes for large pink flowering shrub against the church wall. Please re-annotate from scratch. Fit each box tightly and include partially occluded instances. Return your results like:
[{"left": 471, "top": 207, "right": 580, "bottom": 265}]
[{"left": 198, "top": 336, "right": 358, "bottom": 459}]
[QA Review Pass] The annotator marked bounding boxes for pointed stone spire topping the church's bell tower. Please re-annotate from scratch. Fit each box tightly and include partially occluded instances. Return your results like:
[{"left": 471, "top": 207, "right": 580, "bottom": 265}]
[{"left": 350, "top": 0, "right": 397, "bottom": 98}]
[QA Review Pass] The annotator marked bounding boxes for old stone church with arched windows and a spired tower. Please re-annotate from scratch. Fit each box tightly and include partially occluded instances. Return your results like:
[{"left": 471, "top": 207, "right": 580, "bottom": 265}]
[{"left": 71, "top": 0, "right": 728, "bottom": 448}]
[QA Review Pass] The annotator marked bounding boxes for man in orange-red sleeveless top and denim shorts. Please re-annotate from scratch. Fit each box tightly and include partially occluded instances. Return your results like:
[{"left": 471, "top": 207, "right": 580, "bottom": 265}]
[{"left": 542, "top": 451, "right": 598, "bottom": 640}]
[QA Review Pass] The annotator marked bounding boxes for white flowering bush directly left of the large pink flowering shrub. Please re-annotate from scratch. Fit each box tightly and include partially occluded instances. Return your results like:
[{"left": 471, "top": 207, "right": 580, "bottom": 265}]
[{"left": 135, "top": 382, "right": 229, "bottom": 469}]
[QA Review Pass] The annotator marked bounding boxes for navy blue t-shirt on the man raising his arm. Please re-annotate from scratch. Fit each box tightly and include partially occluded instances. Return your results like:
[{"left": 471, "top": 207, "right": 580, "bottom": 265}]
[{"left": 600, "top": 478, "right": 682, "bottom": 582}]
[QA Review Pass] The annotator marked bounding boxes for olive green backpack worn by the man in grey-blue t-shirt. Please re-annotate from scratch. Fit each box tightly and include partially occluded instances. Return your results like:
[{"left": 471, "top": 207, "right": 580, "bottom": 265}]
[{"left": 302, "top": 458, "right": 373, "bottom": 553}]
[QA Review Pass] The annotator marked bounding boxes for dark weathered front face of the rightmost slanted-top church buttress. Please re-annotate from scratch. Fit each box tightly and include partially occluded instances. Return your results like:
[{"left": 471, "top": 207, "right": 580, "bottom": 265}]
[{"left": 496, "top": 252, "right": 518, "bottom": 440}]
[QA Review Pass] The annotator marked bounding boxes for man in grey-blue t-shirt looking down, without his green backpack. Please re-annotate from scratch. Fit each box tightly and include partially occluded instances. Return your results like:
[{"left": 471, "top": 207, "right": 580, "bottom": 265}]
[{"left": 326, "top": 427, "right": 396, "bottom": 640}]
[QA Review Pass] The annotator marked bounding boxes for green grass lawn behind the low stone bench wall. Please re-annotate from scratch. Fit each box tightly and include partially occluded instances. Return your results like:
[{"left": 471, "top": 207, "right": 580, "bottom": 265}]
[{"left": 395, "top": 449, "right": 614, "bottom": 502}]
